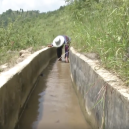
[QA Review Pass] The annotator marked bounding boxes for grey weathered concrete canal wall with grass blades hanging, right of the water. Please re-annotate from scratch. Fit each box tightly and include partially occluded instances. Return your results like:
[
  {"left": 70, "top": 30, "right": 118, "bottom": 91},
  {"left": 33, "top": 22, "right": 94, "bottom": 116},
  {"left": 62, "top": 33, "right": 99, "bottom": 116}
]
[{"left": 70, "top": 48, "right": 129, "bottom": 129}]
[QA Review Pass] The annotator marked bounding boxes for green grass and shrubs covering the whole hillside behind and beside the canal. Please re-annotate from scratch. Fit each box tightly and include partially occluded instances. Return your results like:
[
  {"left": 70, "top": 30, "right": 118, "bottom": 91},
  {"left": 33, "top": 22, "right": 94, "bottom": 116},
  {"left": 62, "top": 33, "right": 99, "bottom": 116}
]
[{"left": 0, "top": 0, "right": 129, "bottom": 84}]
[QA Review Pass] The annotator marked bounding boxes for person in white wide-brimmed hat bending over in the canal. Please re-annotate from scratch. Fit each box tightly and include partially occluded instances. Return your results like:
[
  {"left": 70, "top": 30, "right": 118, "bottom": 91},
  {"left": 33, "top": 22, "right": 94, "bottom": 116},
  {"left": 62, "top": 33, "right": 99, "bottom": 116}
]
[{"left": 48, "top": 35, "right": 71, "bottom": 63}]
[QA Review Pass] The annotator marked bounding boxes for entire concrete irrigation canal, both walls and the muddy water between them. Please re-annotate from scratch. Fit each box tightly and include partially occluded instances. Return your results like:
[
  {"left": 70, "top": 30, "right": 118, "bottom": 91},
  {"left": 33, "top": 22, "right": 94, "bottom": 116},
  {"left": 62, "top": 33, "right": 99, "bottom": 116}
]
[{"left": 0, "top": 48, "right": 129, "bottom": 129}]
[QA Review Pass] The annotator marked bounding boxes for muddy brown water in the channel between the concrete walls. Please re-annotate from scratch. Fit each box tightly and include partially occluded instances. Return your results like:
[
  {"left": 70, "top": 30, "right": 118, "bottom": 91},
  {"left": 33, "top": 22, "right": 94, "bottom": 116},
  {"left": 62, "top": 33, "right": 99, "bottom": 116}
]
[{"left": 18, "top": 61, "right": 91, "bottom": 129}]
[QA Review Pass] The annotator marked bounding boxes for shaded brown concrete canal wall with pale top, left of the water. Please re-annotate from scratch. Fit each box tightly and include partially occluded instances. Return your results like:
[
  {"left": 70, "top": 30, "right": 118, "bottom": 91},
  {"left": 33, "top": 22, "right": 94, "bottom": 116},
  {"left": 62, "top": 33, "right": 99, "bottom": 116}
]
[{"left": 0, "top": 48, "right": 56, "bottom": 129}]
